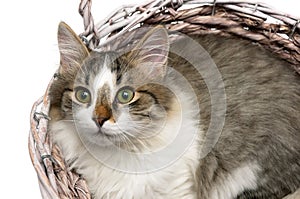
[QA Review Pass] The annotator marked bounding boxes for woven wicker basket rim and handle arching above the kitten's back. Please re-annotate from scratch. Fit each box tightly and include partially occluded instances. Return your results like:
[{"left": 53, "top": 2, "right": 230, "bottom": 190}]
[{"left": 79, "top": 0, "right": 300, "bottom": 74}]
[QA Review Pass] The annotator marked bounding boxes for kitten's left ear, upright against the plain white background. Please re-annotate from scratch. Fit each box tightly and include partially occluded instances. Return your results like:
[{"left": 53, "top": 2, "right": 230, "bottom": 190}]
[{"left": 57, "top": 22, "right": 89, "bottom": 73}]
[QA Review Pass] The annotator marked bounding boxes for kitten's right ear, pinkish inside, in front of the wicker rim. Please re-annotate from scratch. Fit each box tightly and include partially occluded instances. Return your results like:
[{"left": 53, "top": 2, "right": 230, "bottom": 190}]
[{"left": 129, "top": 26, "right": 169, "bottom": 79}]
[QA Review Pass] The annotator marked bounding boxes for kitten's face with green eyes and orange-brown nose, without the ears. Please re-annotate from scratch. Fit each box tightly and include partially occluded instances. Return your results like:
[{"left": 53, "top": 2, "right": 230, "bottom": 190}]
[{"left": 67, "top": 53, "right": 174, "bottom": 147}]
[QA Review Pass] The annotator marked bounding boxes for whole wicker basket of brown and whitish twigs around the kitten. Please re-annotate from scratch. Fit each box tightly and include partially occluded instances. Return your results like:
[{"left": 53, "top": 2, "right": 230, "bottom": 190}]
[{"left": 29, "top": 0, "right": 300, "bottom": 199}]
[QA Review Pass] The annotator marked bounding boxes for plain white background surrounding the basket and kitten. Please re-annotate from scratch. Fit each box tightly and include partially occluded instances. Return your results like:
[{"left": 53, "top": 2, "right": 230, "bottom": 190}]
[{"left": 0, "top": 0, "right": 300, "bottom": 199}]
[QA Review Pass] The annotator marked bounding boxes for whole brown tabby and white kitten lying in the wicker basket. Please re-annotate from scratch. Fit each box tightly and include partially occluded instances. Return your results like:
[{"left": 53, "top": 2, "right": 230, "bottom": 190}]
[{"left": 49, "top": 23, "right": 300, "bottom": 199}]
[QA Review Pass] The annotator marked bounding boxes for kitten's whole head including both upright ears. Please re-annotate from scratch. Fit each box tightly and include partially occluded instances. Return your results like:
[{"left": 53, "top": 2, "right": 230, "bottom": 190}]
[{"left": 50, "top": 23, "right": 178, "bottom": 151}]
